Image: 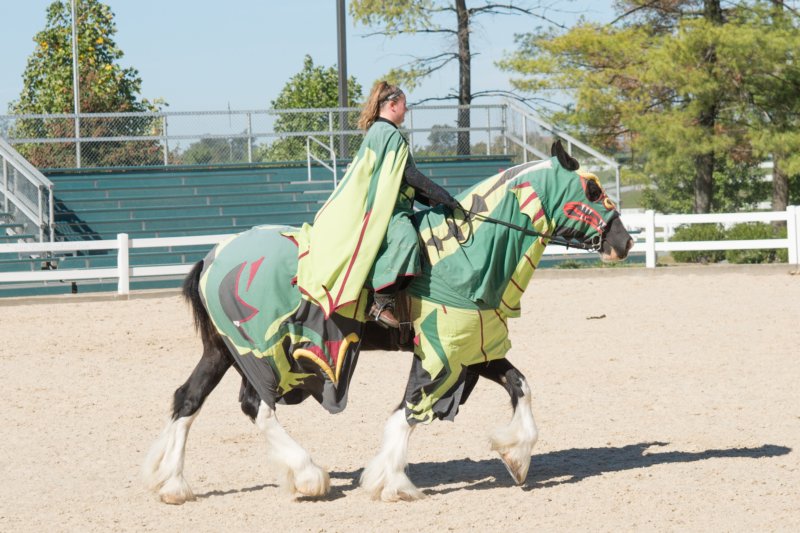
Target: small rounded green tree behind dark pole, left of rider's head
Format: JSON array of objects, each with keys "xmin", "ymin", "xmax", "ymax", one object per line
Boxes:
[{"xmin": 257, "ymin": 55, "xmax": 362, "ymax": 161}]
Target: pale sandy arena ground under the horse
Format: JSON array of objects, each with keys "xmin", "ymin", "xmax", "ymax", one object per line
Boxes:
[{"xmin": 0, "ymin": 266, "xmax": 800, "ymax": 532}]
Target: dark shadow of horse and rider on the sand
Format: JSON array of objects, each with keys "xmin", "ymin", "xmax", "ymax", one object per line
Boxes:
[{"xmin": 192, "ymin": 441, "xmax": 792, "ymax": 501}]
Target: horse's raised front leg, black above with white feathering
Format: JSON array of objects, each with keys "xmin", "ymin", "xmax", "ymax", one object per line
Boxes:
[{"xmin": 470, "ymin": 359, "xmax": 538, "ymax": 485}]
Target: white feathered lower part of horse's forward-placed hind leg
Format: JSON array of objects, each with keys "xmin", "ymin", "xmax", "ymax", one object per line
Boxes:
[{"xmin": 250, "ymin": 400, "xmax": 330, "ymax": 497}]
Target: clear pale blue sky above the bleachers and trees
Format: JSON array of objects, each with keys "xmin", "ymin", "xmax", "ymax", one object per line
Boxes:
[{"xmin": 0, "ymin": 0, "xmax": 613, "ymax": 114}]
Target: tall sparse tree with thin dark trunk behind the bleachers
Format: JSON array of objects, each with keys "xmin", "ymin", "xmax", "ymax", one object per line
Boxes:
[{"xmin": 350, "ymin": 0, "xmax": 564, "ymax": 155}]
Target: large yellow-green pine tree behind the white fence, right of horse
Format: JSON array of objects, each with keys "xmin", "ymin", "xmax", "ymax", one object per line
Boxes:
[{"xmin": 501, "ymin": 0, "xmax": 798, "ymax": 213}]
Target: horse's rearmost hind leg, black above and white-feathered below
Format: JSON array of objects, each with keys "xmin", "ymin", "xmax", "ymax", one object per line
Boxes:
[{"xmin": 142, "ymin": 339, "xmax": 232, "ymax": 504}]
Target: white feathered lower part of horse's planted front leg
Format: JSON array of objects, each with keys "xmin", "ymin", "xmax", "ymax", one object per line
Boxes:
[{"xmin": 361, "ymin": 406, "xmax": 425, "ymax": 502}]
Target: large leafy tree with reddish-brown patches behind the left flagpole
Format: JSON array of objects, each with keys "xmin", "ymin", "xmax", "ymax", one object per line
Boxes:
[{"xmin": 9, "ymin": 0, "xmax": 161, "ymax": 167}]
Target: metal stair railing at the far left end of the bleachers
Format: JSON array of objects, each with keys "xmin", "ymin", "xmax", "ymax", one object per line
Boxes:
[{"xmin": 0, "ymin": 138, "xmax": 55, "ymax": 242}]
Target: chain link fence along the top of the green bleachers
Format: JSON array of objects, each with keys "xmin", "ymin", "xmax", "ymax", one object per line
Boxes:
[{"xmin": 0, "ymin": 105, "xmax": 507, "ymax": 168}]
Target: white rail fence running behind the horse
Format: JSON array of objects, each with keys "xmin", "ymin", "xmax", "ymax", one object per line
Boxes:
[{"xmin": 0, "ymin": 206, "xmax": 800, "ymax": 296}]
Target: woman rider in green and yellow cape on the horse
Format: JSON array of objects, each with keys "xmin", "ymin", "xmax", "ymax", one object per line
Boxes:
[{"xmin": 297, "ymin": 81, "xmax": 459, "ymax": 328}]
